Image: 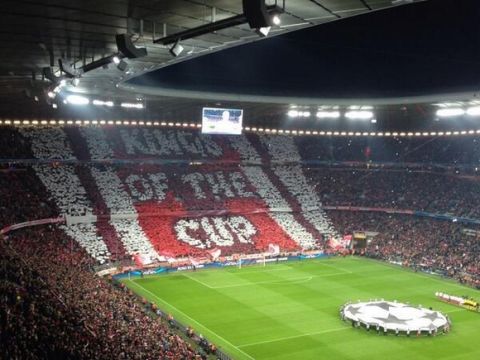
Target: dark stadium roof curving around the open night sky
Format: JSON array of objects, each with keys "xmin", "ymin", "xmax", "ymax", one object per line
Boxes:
[{"xmin": 0, "ymin": 0, "xmax": 478, "ymax": 129}]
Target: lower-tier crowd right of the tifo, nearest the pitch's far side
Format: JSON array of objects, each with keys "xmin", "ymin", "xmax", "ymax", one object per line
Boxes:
[{"xmin": 328, "ymin": 211, "xmax": 480, "ymax": 287}]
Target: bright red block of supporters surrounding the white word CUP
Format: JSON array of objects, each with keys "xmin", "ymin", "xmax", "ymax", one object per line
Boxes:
[{"xmin": 129, "ymin": 166, "xmax": 298, "ymax": 257}]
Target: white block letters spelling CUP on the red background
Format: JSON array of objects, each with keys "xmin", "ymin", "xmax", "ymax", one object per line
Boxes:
[{"xmin": 175, "ymin": 216, "xmax": 257, "ymax": 249}]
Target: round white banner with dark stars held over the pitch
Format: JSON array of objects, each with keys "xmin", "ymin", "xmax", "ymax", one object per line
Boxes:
[{"xmin": 340, "ymin": 300, "xmax": 450, "ymax": 336}]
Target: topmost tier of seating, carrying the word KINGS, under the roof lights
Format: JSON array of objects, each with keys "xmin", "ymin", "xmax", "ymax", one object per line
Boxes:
[{"xmin": 0, "ymin": 126, "xmax": 480, "ymax": 165}]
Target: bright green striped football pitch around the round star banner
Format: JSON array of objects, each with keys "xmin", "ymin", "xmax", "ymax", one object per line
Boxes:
[{"xmin": 124, "ymin": 257, "xmax": 480, "ymax": 360}]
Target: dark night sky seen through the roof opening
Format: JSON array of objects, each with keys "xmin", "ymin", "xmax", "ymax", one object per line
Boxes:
[{"xmin": 133, "ymin": 0, "xmax": 480, "ymax": 98}]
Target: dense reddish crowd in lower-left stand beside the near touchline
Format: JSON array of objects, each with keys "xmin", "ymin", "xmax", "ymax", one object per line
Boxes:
[{"xmin": 0, "ymin": 227, "xmax": 204, "ymax": 360}]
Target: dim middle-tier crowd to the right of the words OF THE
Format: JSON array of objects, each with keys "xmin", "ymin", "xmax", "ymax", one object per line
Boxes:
[{"xmin": 305, "ymin": 167, "xmax": 480, "ymax": 219}]
